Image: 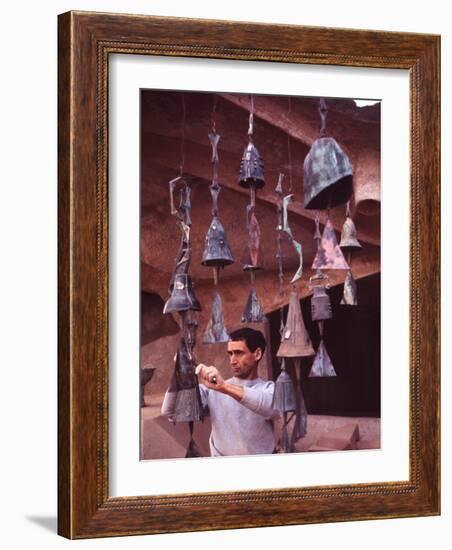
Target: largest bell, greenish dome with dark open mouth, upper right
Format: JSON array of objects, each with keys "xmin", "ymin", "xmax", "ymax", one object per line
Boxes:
[{"xmin": 303, "ymin": 137, "xmax": 353, "ymax": 210}]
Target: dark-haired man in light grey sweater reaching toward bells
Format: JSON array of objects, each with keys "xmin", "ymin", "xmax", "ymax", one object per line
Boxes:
[{"xmin": 162, "ymin": 328, "xmax": 279, "ymax": 456}]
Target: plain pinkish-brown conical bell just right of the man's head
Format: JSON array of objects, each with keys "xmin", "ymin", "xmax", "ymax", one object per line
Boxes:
[{"xmin": 276, "ymin": 291, "xmax": 315, "ymax": 357}]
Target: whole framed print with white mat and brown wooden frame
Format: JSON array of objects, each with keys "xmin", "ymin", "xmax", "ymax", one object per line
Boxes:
[{"xmin": 59, "ymin": 12, "xmax": 439, "ymax": 538}]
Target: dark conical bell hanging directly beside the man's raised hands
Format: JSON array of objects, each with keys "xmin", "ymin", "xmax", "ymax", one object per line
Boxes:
[{"xmin": 172, "ymin": 338, "xmax": 204, "ymax": 422}]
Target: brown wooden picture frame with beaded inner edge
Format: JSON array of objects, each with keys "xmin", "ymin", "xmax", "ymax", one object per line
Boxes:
[{"xmin": 58, "ymin": 12, "xmax": 440, "ymax": 538}]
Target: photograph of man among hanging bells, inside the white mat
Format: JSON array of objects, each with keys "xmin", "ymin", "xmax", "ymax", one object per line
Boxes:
[{"xmin": 140, "ymin": 89, "xmax": 381, "ymax": 460}]
